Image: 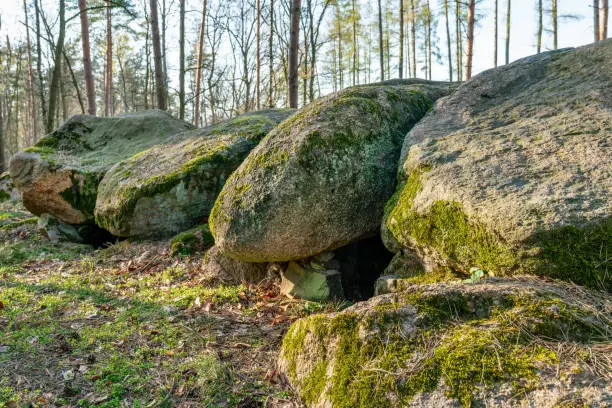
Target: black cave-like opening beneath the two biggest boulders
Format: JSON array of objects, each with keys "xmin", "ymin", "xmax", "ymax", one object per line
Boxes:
[{"xmin": 334, "ymin": 234, "xmax": 393, "ymax": 301}]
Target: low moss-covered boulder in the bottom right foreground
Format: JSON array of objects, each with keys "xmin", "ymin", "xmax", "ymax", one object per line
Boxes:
[{"xmin": 278, "ymin": 278, "xmax": 612, "ymax": 408}]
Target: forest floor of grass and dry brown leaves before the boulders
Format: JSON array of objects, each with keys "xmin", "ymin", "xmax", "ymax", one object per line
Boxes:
[{"xmin": 0, "ymin": 197, "xmax": 340, "ymax": 408}]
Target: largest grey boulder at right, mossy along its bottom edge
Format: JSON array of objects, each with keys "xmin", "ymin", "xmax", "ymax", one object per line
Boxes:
[{"xmin": 382, "ymin": 40, "xmax": 612, "ymax": 290}]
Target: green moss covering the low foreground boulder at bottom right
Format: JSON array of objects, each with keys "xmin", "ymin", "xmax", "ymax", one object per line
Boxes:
[{"xmin": 282, "ymin": 291, "xmax": 607, "ymax": 407}]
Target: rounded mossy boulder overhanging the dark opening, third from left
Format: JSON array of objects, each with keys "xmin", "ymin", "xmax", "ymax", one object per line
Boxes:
[{"xmin": 210, "ymin": 80, "xmax": 450, "ymax": 262}]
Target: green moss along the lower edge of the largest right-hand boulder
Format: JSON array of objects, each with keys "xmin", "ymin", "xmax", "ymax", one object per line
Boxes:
[{"xmin": 384, "ymin": 165, "xmax": 612, "ymax": 290}]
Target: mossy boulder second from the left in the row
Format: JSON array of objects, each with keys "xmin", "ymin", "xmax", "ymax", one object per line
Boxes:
[{"xmin": 95, "ymin": 109, "xmax": 294, "ymax": 237}]
